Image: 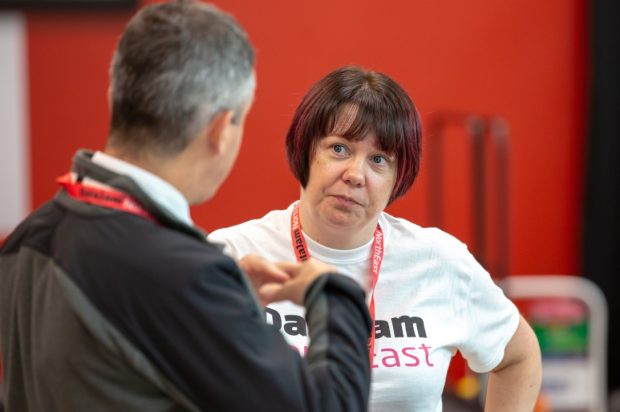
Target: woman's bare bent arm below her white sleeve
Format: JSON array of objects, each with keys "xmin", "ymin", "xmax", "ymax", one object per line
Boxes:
[{"xmin": 484, "ymin": 317, "xmax": 542, "ymax": 412}]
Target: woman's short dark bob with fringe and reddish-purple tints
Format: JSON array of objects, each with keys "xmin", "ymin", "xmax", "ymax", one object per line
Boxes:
[{"xmin": 286, "ymin": 66, "xmax": 422, "ymax": 203}]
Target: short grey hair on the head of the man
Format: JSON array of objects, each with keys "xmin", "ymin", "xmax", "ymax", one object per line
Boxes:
[{"xmin": 108, "ymin": 0, "xmax": 256, "ymax": 155}]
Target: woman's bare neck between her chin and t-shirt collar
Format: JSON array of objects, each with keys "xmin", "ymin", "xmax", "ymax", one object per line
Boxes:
[{"xmin": 298, "ymin": 200, "xmax": 377, "ymax": 250}]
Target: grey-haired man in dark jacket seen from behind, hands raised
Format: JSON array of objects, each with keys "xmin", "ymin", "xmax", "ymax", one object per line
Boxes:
[{"xmin": 0, "ymin": 0, "xmax": 370, "ymax": 411}]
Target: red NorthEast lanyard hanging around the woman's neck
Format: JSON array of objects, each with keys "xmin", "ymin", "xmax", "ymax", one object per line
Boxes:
[{"xmin": 291, "ymin": 205, "xmax": 383, "ymax": 367}]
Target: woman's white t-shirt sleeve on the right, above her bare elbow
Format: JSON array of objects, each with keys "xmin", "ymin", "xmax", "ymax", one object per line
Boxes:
[{"xmin": 460, "ymin": 252, "xmax": 520, "ymax": 373}]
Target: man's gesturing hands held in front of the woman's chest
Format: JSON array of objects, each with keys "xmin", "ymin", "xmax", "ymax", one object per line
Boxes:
[{"xmin": 257, "ymin": 258, "xmax": 336, "ymax": 305}]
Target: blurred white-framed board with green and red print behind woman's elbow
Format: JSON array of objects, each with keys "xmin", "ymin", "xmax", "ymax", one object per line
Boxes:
[{"xmin": 501, "ymin": 275, "xmax": 608, "ymax": 412}]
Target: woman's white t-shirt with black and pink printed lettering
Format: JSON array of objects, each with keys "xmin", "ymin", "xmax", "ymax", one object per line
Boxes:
[{"xmin": 209, "ymin": 204, "xmax": 519, "ymax": 412}]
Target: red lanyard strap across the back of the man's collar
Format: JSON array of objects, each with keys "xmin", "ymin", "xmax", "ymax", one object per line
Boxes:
[{"xmin": 56, "ymin": 173, "xmax": 156, "ymax": 222}]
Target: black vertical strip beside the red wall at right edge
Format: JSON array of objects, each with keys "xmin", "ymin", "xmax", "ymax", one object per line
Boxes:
[{"xmin": 582, "ymin": 0, "xmax": 620, "ymax": 412}]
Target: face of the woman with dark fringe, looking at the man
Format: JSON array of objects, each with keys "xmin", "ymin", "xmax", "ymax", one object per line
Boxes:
[{"xmin": 301, "ymin": 133, "xmax": 397, "ymax": 235}]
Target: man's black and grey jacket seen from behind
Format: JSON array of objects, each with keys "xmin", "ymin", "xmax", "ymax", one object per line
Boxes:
[{"xmin": 0, "ymin": 151, "xmax": 370, "ymax": 412}]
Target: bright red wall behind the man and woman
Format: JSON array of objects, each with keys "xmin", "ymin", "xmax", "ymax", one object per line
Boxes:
[{"xmin": 27, "ymin": 0, "xmax": 588, "ymax": 274}]
